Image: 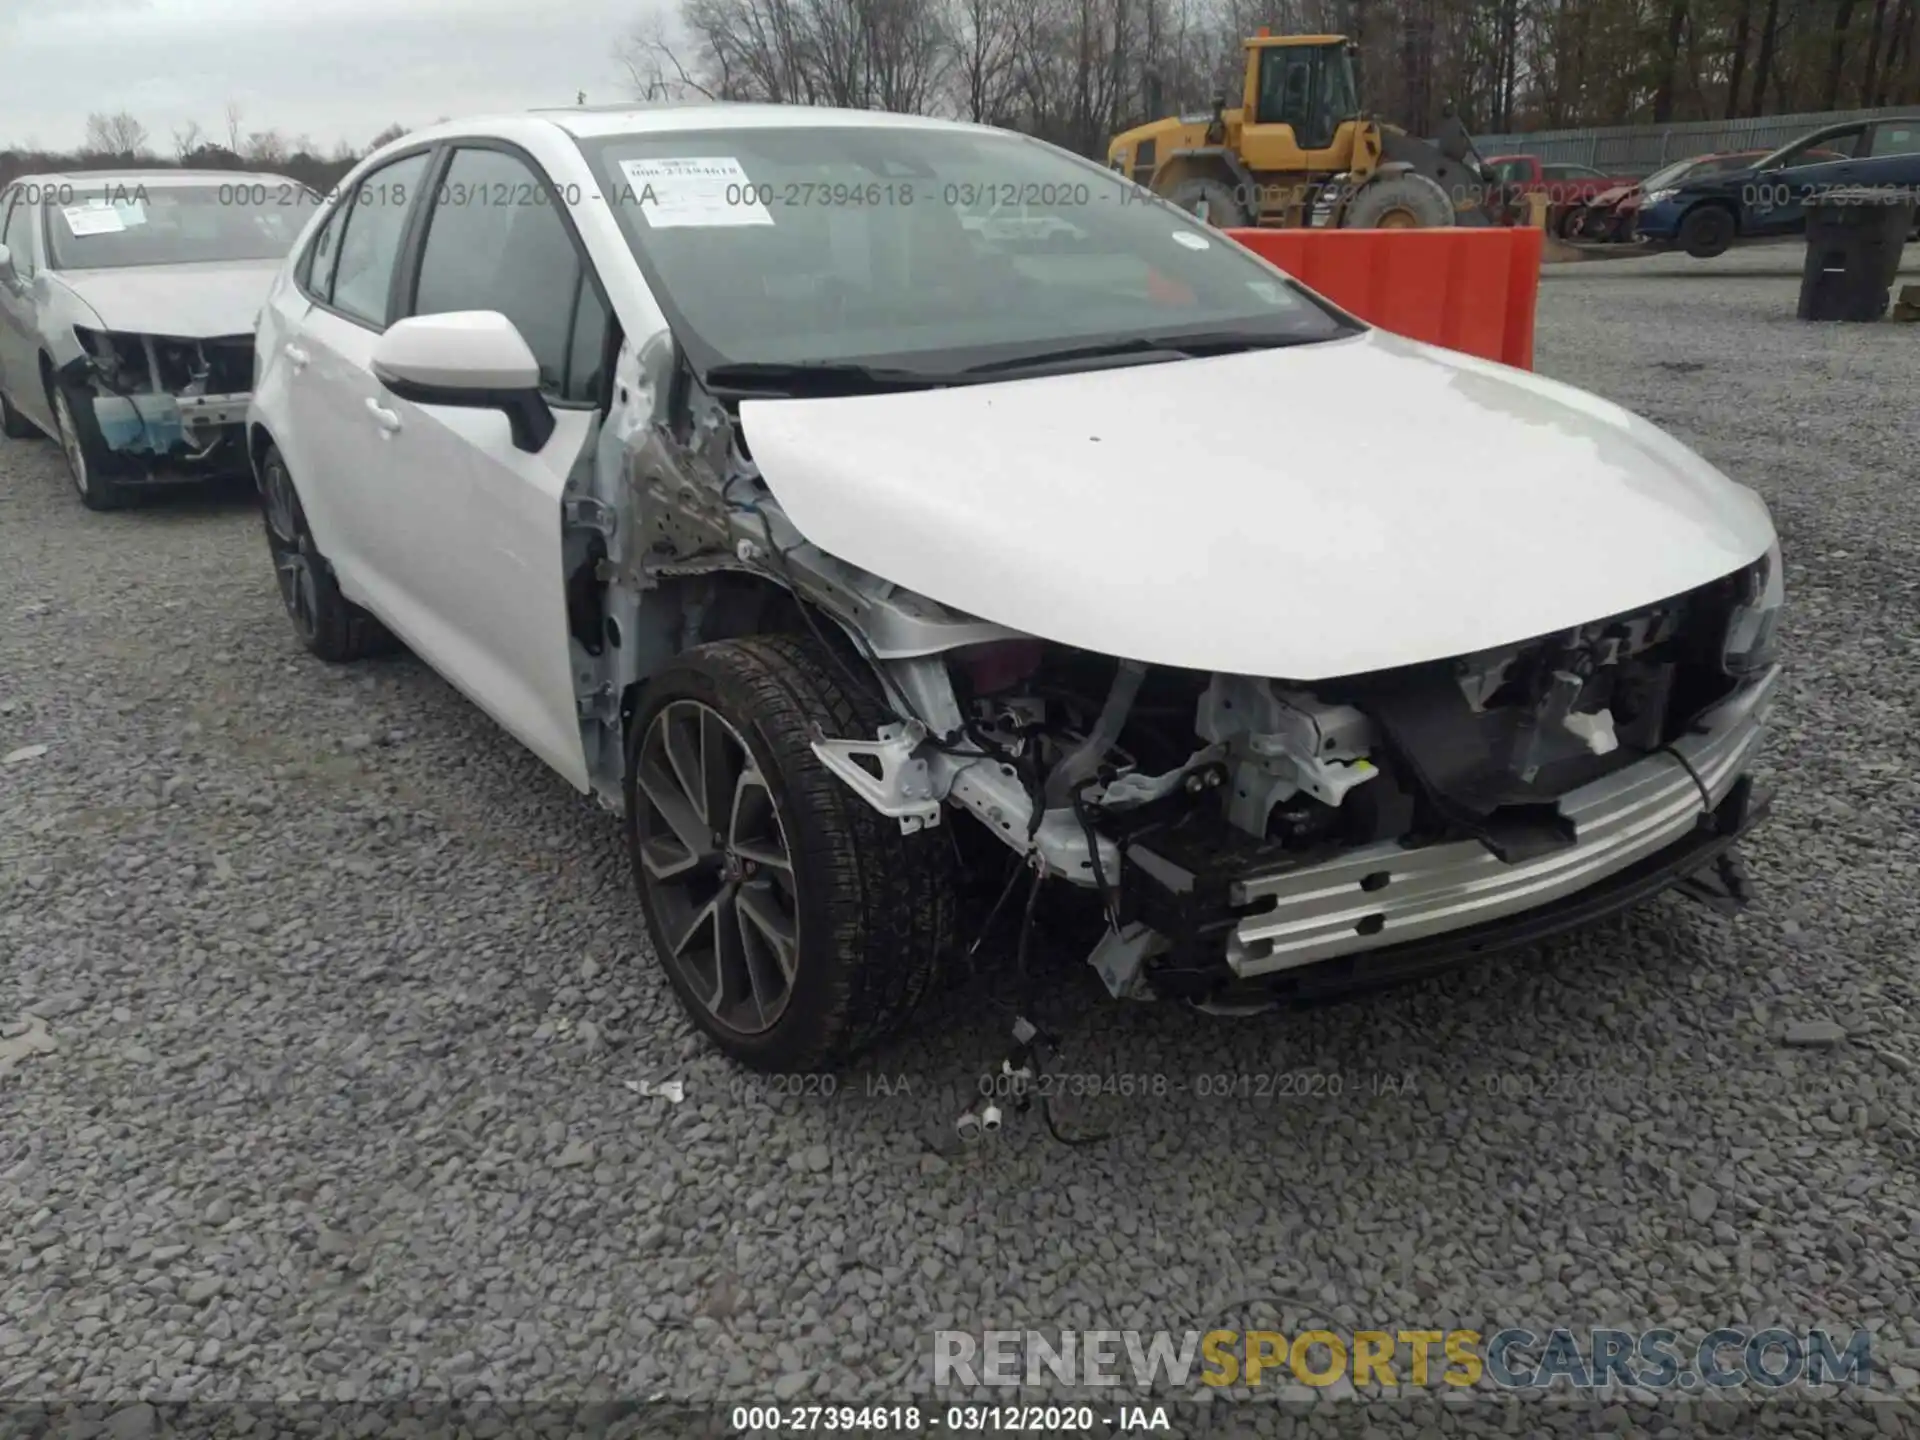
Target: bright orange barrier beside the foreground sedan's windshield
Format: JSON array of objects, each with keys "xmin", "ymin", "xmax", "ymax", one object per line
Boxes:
[{"xmin": 1227, "ymin": 225, "xmax": 1542, "ymax": 371}]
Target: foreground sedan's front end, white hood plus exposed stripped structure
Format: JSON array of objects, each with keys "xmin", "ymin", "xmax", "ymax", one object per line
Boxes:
[{"xmin": 566, "ymin": 318, "xmax": 1784, "ymax": 1008}]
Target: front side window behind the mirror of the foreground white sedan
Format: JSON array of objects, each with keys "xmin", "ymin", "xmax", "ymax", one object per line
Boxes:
[{"xmin": 411, "ymin": 148, "xmax": 607, "ymax": 399}]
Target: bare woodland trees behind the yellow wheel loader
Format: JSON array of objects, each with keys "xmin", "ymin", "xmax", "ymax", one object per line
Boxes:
[{"xmin": 620, "ymin": 0, "xmax": 1920, "ymax": 156}]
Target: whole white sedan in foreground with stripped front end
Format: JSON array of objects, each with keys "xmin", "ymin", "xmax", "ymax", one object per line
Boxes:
[{"xmin": 248, "ymin": 106, "xmax": 1782, "ymax": 1071}]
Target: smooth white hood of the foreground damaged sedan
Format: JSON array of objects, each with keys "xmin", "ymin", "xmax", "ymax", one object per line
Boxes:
[{"xmin": 741, "ymin": 330, "xmax": 1774, "ymax": 680}]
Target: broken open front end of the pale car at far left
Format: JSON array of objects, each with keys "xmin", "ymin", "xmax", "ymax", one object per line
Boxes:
[{"xmin": 61, "ymin": 326, "xmax": 253, "ymax": 467}]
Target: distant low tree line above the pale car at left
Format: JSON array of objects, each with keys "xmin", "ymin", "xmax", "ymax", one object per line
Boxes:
[{"xmin": 0, "ymin": 104, "xmax": 407, "ymax": 194}]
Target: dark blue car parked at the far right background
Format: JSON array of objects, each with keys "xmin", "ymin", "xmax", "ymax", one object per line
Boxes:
[{"xmin": 1636, "ymin": 115, "xmax": 1920, "ymax": 259}]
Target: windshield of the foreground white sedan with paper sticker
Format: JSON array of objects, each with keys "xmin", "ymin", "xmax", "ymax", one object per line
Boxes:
[{"xmin": 584, "ymin": 127, "xmax": 1357, "ymax": 372}]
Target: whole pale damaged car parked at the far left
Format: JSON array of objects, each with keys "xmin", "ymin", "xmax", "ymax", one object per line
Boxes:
[{"xmin": 0, "ymin": 169, "xmax": 319, "ymax": 511}]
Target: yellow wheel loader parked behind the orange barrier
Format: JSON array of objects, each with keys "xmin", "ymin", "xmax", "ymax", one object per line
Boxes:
[{"xmin": 1106, "ymin": 29, "xmax": 1511, "ymax": 228}]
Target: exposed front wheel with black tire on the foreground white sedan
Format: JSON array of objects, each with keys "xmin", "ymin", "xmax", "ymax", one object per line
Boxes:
[{"xmin": 626, "ymin": 636, "xmax": 954, "ymax": 1073}]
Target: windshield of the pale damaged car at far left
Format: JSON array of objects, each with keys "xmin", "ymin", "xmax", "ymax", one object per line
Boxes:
[{"xmin": 46, "ymin": 177, "xmax": 317, "ymax": 271}]
